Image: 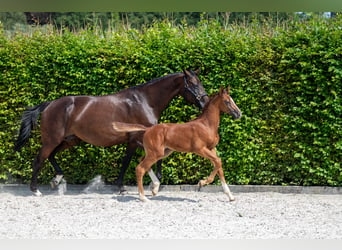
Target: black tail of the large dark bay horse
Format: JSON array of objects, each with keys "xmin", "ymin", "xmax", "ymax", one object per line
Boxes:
[{"xmin": 14, "ymin": 102, "xmax": 50, "ymax": 151}]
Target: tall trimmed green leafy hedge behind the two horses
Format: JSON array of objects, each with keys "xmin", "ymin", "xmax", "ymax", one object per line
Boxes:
[{"xmin": 0, "ymin": 17, "xmax": 342, "ymax": 186}]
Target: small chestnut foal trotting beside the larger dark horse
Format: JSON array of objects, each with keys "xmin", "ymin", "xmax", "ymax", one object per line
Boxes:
[{"xmin": 113, "ymin": 88, "xmax": 241, "ymax": 201}]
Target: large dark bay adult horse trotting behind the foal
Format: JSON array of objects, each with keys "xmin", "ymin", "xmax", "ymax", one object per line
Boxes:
[{"xmin": 15, "ymin": 70, "xmax": 209, "ymax": 196}]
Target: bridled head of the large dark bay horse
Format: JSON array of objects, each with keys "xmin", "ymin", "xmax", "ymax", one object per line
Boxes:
[{"xmin": 180, "ymin": 69, "xmax": 209, "ymax": 108}]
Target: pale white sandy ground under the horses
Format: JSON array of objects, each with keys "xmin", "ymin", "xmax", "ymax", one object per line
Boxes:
[{"xmin": 0, "ymin": 182, "xmax": 342, "ymax": 239}]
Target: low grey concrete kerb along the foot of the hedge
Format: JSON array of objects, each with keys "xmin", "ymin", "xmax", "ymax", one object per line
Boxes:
[{"xmin": 0, "ymin": 184, "xmax": 342, "ymax": 195}]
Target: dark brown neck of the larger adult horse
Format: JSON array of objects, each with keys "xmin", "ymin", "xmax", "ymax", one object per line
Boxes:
[{"xmin": 141, "ymin": 74, "xmax": 180, "ymax": 118}]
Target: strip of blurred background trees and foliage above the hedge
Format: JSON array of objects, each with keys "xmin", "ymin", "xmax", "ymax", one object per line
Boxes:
[{"xmin": 0, "ymin": 12, "xmax": 296, "ymax": 31}]
